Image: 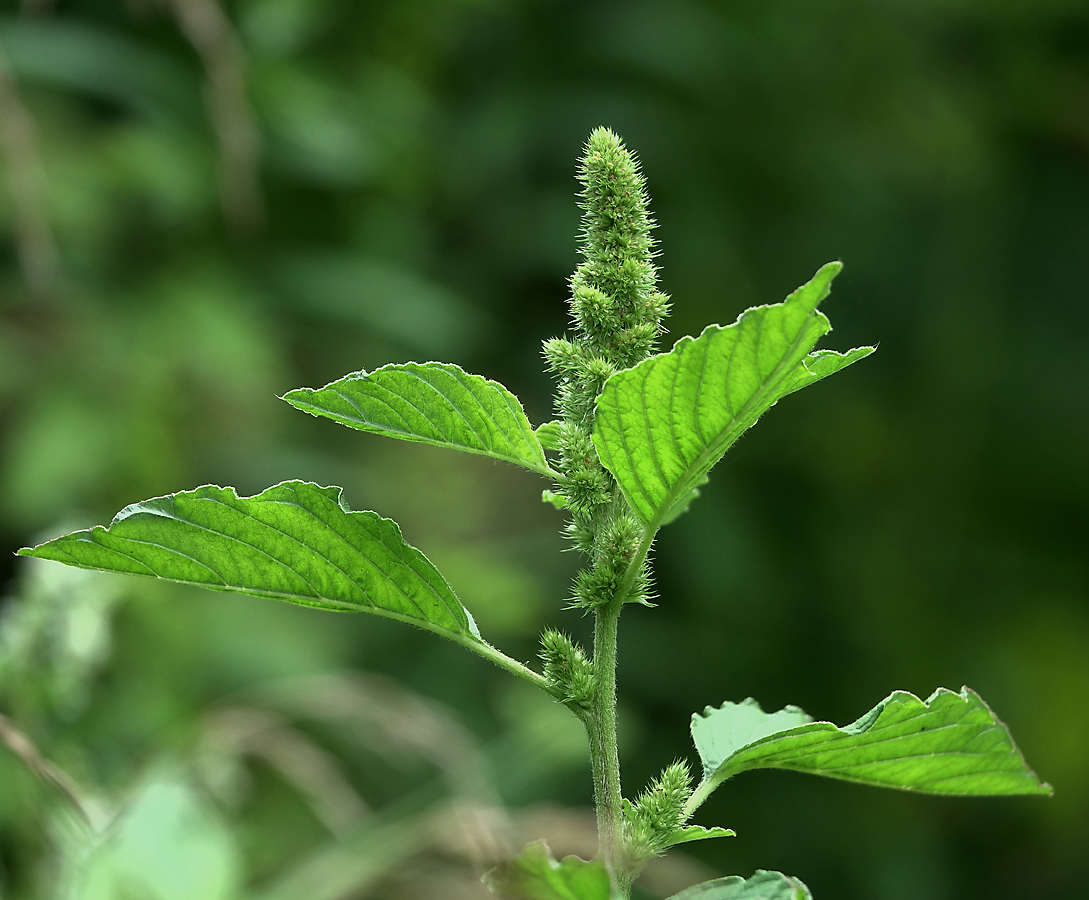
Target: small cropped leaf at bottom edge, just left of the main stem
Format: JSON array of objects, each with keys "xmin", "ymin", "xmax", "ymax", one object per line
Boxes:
[{"xmin": 484, "ymin": 841, "xmax": 612, "ymax": 900}]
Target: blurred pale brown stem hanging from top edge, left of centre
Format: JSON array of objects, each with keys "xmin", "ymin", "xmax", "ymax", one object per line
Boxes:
[{"xmin": 170, "ymin": 0, "xmax": 265, "ymax": 232}]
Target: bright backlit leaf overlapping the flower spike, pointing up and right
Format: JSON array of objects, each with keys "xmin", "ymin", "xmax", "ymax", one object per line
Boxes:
[{"xmin": 594, "ymin": 263, "xmax": 873, "ymax": 528}]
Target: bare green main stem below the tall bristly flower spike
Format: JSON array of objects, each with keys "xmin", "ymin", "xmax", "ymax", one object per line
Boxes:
[{"xmin": 587, "ymin": 600, "xmax": 626, "ymax": 896}]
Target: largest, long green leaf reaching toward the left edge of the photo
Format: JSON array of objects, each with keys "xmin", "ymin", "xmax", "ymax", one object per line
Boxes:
[{"xmin": 20, "ymin": 482, "xmax": 479, "ymax": 642}]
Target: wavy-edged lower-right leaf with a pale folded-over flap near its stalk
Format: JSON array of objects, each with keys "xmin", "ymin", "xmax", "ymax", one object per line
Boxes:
[{"xmin": 687, "ymin": 688, "xmax": 1051, "ymax": 812}]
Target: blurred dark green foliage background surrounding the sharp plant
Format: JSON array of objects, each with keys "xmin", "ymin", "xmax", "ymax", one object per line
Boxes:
[{"xmin": 0, "ymin": 0, "xmax": 1089, "ymax": 900}]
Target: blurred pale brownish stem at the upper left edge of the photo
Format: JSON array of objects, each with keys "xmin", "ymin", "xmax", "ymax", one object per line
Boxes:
[{"xmin": 0, "ymin": 46, "xmax": 60, "ymax": 297}]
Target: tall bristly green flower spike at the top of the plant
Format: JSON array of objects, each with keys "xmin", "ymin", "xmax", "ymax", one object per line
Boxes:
[{"xmin": 545, "ymin": 129, "xmax": 670, "ymax": 608}]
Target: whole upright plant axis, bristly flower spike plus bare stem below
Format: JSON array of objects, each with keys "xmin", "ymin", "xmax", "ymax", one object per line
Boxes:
[{"xmin": 544, "ymin": 129, "xmax": 670, "ymax": 898}]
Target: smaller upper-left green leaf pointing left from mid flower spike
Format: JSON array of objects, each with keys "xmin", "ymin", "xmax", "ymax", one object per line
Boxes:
[{"xmin": 283, "ymin": 363, "xmax": 555, "ymax": 476}]
